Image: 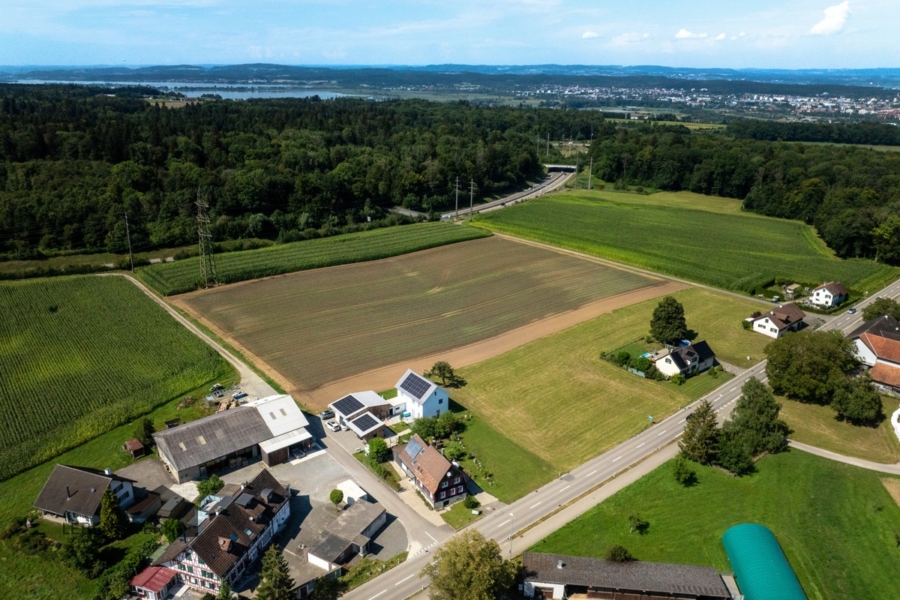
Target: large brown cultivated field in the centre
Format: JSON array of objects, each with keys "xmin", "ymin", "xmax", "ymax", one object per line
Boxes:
[{"xmin": 179, "ymin": 238, "xmax": 658, "ymax": 390}]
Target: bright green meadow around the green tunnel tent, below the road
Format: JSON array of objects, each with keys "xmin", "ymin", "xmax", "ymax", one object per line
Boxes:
[{"xmin": 531, "ymin": 450, "xmax": 900, "ymax": 600}]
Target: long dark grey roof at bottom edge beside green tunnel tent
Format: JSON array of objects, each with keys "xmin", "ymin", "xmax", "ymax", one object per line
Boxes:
[{"xmin": 522, "ymin": 552, "xmax": 731, "ymax": 600}]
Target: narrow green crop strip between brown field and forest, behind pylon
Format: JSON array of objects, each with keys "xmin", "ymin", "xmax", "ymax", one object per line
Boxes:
[{"xmin": 138, "ymin": 223, "xmax": 486, "ymax": 296}]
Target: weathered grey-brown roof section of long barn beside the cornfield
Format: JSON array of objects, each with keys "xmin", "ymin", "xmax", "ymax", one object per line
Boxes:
[{"xmin": 153, "ymin": 406, "xmax": 272, "ymax": 471}]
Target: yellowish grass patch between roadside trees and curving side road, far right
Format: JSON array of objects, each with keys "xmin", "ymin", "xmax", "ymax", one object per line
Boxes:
[{"xmin": 779, "ymin": 397, "xmax": 900, "ymax": 464}]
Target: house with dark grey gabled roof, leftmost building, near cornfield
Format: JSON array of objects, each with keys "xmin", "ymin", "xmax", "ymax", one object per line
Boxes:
[{"xmin": 34, "ymin": 465, "xmax": 134, "ymax": 527}]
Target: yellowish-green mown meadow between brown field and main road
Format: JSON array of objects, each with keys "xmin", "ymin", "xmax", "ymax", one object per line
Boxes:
[{"xmin": 452, "ymin": 288, "xmax": 771, "ymax": 488}]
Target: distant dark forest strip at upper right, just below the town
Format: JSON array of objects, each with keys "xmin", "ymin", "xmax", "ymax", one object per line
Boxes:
[{"xmin": 727, "ymin": 119, "xmax": 900, "ymax": 146}]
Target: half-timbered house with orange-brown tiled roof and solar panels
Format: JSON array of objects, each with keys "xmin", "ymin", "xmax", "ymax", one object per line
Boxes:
[{"xmin": 392, "ymin": 434, "xmax": 466, "ymax": 508}]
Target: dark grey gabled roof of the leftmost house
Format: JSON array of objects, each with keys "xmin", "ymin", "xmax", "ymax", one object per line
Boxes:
[{"xmin": 34, "ymin": 465, "xmax": 123, "ymax": 517}]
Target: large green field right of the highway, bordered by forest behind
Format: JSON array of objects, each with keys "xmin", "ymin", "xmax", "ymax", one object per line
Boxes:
[{"xmin": 476, "ymin": 190, "xmax": 900, "ymax": 292}]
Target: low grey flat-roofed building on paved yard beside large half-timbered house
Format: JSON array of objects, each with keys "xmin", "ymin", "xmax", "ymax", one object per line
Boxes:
[{"xmin": 302, "ymin": 499, "xmax": 387, "ymax": 572}]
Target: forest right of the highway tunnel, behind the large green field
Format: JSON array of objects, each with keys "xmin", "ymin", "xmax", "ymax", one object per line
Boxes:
[{"xmin": 591, "ymin": 125, "xmax": 900, "ymax": 264}]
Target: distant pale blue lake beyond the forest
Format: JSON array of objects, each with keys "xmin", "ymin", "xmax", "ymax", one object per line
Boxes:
[{"xmin": 16, "ymin": 79, "xmax": 352, "ymax": 100}]
